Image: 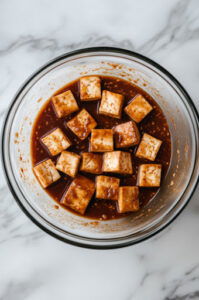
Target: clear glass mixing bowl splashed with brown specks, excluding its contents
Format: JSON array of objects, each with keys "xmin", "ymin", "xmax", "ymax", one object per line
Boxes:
[{"xmin": 2, "ymin": 47, "xmax": 199, "ymax": 249}]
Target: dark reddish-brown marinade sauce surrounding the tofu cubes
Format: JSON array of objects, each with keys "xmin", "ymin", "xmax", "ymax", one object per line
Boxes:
[{"xmin": 31, "ymin": 76, "xmax": 171, "ymax": 219}]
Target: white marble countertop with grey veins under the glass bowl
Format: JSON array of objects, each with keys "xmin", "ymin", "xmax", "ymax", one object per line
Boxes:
[{"xmin": 0, "ymin": 0, "xmax": 199, "ymax": 300}]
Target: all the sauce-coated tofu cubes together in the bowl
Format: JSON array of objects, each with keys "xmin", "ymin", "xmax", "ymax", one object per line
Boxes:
[{"xmin": 34, "ymin": 76, "xmax": 162, "ymax": 215}]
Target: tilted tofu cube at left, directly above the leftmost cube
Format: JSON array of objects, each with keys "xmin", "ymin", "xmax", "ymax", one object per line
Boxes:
[{"xmin": 41, "ymin": 128, "xmax": 71, "ymax": 156}]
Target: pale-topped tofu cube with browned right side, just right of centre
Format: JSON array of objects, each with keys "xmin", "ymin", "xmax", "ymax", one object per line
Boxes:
[{"xmin": 102, "ymin": 151, "xmax": 133, "ymax": 174}]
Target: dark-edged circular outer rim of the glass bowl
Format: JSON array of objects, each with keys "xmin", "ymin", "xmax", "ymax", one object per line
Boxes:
[{"xmin": 1, "ymin": 46, "xmax": 199, "ymax": 250}]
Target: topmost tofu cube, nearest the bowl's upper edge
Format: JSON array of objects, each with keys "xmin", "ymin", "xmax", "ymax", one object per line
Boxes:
[{"xmin": 80, "ymin": 76, "xmax": 101, "ymax": 101}]
